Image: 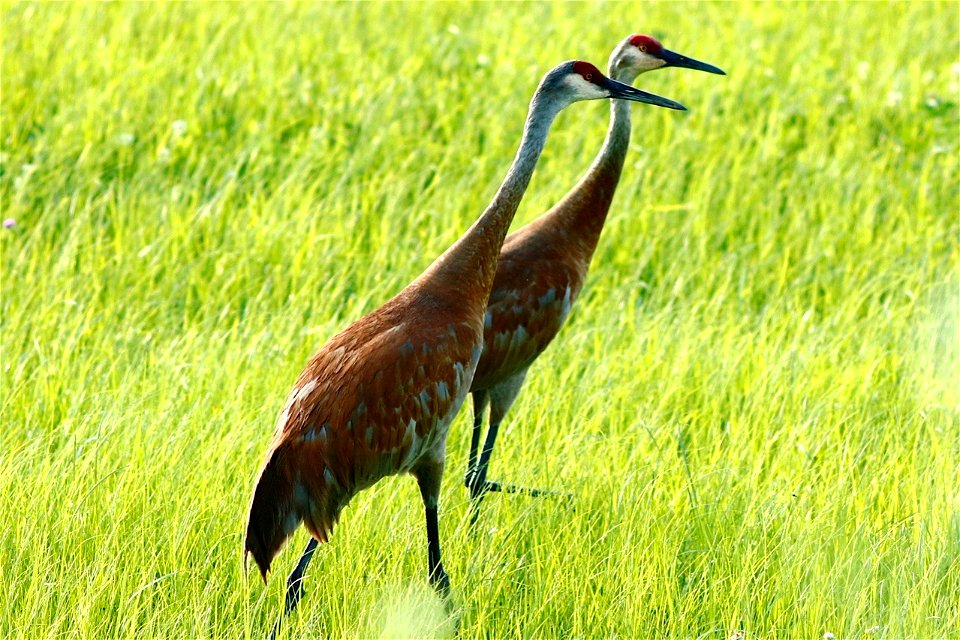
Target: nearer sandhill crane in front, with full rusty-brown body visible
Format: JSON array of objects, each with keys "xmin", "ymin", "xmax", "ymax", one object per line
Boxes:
[{"xmin": 244, "ymin": 61, "xmax": 684, "ymax": 635}]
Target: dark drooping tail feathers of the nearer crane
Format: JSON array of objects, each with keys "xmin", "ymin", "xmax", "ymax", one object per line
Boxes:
[{"xmin": 243, "ymin": 449, "xmax": 302, "ymax": 582}]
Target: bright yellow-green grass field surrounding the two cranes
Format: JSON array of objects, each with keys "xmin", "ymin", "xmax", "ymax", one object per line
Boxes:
[{"xmin": 0, "ymin": 2, "xmax": 960, "ymax": 639}]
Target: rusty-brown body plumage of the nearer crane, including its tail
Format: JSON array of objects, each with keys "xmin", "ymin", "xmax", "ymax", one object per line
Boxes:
[{"xmin": 246, "ymin": 290, "xmax": 480, "ymax": 577}]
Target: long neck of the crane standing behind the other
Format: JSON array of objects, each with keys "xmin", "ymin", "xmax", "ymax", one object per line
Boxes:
[{"xmin": 552, "ymin": 67, "xmax": 636, "ymax": 250}]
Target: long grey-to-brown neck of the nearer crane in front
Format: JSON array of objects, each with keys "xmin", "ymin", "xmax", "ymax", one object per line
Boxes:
[{"xmin": 417, "ymin": 92, "xmax": 563, "ymax": 308}]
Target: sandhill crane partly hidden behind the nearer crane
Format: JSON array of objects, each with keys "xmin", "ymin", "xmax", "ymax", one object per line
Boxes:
[{"xmin": 464, "ymin": 35, "xmax": 725, "ymax": 522}]
